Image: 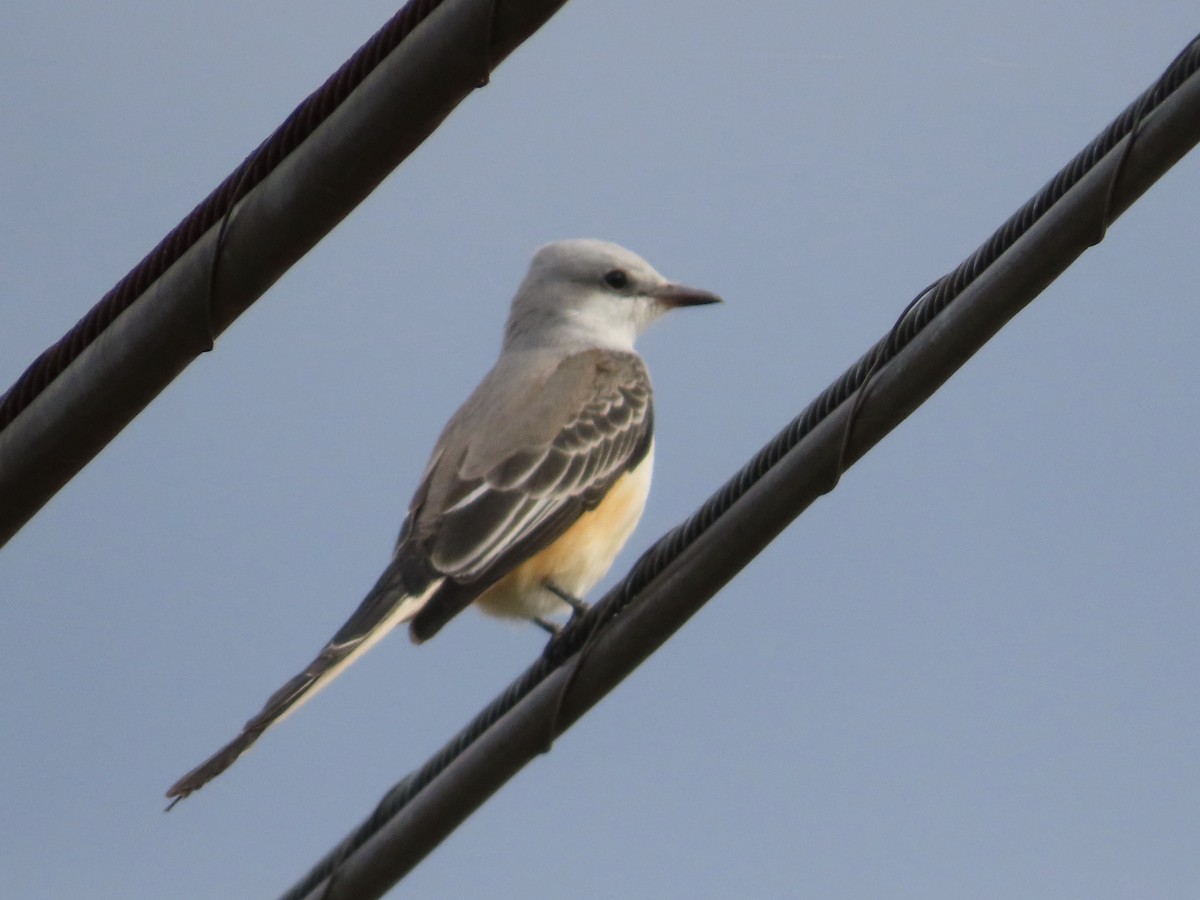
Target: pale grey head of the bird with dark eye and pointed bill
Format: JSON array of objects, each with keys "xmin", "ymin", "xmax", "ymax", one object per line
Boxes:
[{"xmin": 504, "ymin": 239, "xmax": 720, "ymax": 350}]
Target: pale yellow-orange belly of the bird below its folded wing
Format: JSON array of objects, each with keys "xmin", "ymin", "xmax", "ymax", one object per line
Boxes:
[{"xmin": 475, "ymin": 444, "xmax": 654, "ymax": 619}]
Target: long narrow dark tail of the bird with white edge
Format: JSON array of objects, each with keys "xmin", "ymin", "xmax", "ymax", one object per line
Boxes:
[{"xmin": 167, "ymin": 560, "xmax": 440, "ymax": 811}]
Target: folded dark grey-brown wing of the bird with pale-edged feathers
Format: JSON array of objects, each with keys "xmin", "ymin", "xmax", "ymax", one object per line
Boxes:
[{"xmin": 406, "ymin": 350, "xmax": 653, "ymax": 640}]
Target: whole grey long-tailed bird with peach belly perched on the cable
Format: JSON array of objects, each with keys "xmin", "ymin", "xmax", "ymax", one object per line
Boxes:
[{"xmin": 167, "ymin": 240, "xmax": 720, "ymax": 799}]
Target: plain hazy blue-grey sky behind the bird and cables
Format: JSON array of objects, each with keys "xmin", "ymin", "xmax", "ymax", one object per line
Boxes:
[{"xmin": 0, "ymin": 0, "xmax": 1200, "ymax": 900}]
